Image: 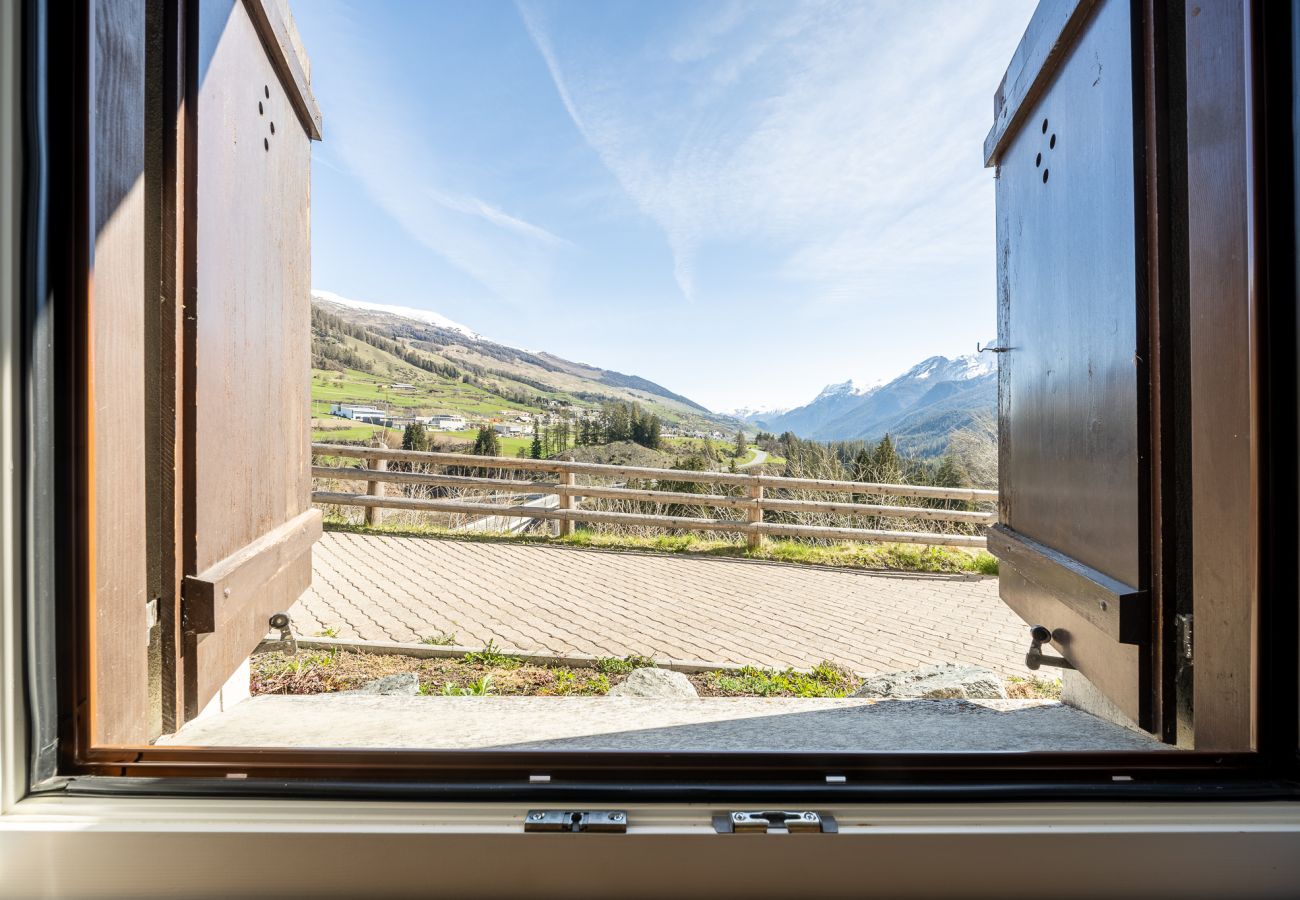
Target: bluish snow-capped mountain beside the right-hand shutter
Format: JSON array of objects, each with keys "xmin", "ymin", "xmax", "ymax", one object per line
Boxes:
[{"xmin": 746, "ymin": 345, "xmax": 997, "ymax": 454}]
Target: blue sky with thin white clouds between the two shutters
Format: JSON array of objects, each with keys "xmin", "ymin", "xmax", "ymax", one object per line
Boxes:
[{"xmin": 293, "ymin": 0, "xmax": 1034, "ymax": 410}]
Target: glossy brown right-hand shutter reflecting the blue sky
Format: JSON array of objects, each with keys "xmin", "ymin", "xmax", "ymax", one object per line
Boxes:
[{"xmin": 988, "ymin": 0, "xmax": 1152, "ymax": 728}]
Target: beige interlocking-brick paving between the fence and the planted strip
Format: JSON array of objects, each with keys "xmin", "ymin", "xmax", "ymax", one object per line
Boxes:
[{"xmin": 293, "ymin": 532, "xmax": 1028, "ymax": 675}]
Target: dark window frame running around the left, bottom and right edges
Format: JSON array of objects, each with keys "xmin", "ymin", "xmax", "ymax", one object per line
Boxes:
[{"xmin": 4, "ymin": 0, "xmax": 1300, "ymax": 804}]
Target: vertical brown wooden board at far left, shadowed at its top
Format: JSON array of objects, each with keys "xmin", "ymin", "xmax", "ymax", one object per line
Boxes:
[{"xmin": 81, "ymin": 0, "xmax": 152, "ymax": 745}]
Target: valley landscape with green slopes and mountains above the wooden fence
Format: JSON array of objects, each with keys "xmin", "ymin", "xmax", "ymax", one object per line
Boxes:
[{"xmin": 312, "ymin": 291, "xmax": 997, "ymax": 484}]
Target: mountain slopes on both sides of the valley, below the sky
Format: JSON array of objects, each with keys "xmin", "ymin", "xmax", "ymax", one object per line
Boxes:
[{"xmin": 312, "ymin": 290, "xmax": 997, "ymax": 457}]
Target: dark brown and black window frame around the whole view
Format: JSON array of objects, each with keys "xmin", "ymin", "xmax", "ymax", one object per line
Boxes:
[{"xmin": 12, "ymin": 0, "xmax": 1300, "ymax": 802}]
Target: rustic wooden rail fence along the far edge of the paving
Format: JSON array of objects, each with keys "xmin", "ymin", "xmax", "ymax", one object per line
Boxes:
[{"xmin": 312, "ymin": 443, "xmax": 997, "ymax": 548}]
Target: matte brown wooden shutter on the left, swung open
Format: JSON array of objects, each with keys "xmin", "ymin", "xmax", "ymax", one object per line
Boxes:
[{"xmin": 182, "ymin": 0, "xmax": 320, "ymax": 718}]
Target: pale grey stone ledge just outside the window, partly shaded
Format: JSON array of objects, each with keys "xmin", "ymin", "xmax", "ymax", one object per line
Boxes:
[{"xmin": 160, "ymin": 693, "xmax": 1164, "ymax": 753}]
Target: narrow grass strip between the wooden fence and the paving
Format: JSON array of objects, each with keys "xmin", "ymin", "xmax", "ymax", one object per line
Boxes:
[{"xmin": 325, "ymin": 518, "xmax": 997, "ymax": 575}]
